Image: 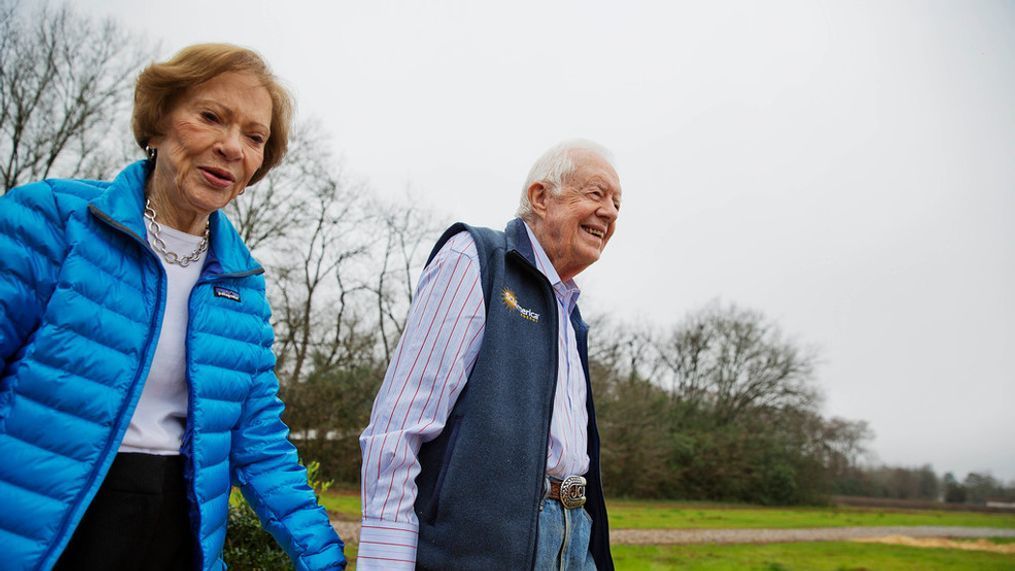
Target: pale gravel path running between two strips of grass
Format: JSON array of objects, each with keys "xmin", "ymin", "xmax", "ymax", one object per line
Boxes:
[{"xmin": 331, "ymin": 519, "xmax": 1015, "ymax": 546}]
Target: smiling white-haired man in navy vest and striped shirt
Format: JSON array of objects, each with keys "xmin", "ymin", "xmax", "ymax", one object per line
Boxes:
[{"xmin": 357, "ymin": 141, "xmax": 620, "ymax": 571}]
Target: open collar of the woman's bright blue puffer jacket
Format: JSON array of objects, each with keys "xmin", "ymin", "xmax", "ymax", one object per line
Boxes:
[{"xmin": 89, "ymin": 160, "xmax": 261, "ymax": 274}]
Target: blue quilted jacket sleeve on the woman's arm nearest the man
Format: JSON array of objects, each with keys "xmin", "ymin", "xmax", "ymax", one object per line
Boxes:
[{"xmin": 230, "ymin": 320, "xmax": 345, "ymax": 571}]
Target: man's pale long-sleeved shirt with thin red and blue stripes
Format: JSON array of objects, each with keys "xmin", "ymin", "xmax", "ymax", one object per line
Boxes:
[{"xmin": 356, "ymin": 225, "xmax": 589, "ymax": 571}]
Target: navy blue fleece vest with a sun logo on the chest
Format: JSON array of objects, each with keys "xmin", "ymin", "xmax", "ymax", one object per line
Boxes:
[{"xmin": 414, "ymin": 219, "xmax": 613, "ymax": 571}]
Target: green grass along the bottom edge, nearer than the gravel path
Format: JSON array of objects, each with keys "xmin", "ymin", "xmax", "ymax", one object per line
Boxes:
[{"xmin": 612, "ymin": 542, "xmax": 1015, "ymax": 571}]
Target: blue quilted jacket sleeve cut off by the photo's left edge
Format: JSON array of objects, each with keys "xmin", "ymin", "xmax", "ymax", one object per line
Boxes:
[{"xmin": 0, "ymin": 182, "xmax": 66, "ymax": 365}]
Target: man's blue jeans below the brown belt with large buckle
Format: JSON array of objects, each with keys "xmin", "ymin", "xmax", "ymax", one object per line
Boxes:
[{"xmin": 536, "ymin": 488, "xmax": 596, "ymax": 571}]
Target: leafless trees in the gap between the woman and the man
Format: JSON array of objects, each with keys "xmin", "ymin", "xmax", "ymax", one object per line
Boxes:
[{"xmin": 227, "ymin": 127, "xmax": 448, "ymax": 481}]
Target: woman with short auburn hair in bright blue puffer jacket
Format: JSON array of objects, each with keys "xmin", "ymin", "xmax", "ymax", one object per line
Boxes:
[{"xmin": 0, "ymin": 45, "xmax": 345, "ymax": 570}]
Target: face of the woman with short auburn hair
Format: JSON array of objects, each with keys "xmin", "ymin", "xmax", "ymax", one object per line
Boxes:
[{"xmin": 149, "ymin": 72, "xmax": 272, "ymax": 222}]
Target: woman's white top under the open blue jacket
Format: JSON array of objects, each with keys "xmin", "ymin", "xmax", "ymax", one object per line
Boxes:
[{"xmin": 120, "ymin": 226, "xmax": 208, "ymax": 455}]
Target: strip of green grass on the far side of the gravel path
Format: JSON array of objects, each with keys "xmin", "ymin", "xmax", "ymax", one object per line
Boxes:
[{"xmin": 321, "ymin": 493, "xmax": 1015, "ymax": 529}]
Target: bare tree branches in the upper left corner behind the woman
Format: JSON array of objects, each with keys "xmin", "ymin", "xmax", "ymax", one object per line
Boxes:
[{"xmin": 0, "ymin": 0, "xmax": 152, "ymax": 192}]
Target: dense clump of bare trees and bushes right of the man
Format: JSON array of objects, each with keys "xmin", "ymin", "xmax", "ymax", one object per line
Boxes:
[{"xmin": 591, "ymin": 303, "xmax": 870, "ymax": 504}]
